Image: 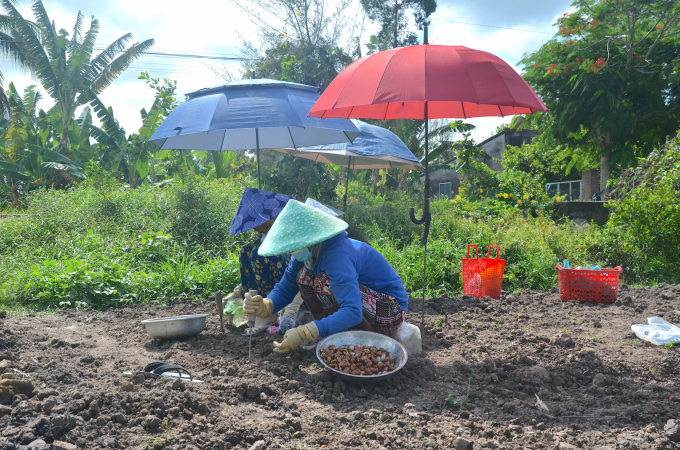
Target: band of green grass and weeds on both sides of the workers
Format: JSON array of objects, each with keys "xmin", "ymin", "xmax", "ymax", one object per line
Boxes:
[{"xmin": 0, "ymin": 178, "xmax": 599, "ymax": 310}]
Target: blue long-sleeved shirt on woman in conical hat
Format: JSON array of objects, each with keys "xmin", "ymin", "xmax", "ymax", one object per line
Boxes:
[{"xmin": 269, "ymin": 231, "xmax": 408, "ymax": 337}]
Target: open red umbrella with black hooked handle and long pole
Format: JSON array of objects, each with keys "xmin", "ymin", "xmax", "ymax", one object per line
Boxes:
[{"xmin": 309, "ymin": 26, "xmax": 548, "ymax": 324}]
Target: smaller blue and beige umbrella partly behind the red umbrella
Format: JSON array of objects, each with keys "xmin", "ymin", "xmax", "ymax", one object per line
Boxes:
[{"xmin": 276, "ymin": 119, "xmax": 424, "ymax": 211}]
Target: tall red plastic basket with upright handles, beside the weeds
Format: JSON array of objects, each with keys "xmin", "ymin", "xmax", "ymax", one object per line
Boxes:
[{"xmin": 461, "ymin": 244, "xmax": 505, "ymax": 298}]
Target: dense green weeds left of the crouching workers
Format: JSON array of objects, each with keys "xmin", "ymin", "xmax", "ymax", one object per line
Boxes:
[{"xmin": 0, "ymin": 177, "xmax": 247, "ymax": 308}]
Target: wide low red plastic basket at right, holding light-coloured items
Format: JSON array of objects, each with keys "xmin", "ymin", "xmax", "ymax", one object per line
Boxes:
[{"xmin": 556, "ymin": 264, "xmax": 623, "ymax": 305}]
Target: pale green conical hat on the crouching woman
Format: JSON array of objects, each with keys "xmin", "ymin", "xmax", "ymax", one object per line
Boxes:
[{"xmin": 257, "ymin": 200, "xmax": 348, "ymax": 256}]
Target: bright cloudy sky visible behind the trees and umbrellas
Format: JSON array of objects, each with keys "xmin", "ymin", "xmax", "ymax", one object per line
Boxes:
[{"xmin": 0, "ymin": 0, "xmax": 572, "ymax": 141}]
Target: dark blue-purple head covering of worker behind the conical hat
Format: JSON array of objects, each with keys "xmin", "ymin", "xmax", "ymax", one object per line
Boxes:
[{"xmin": 229, "ymin": 188, "xmax": 295, "ymax": 236}]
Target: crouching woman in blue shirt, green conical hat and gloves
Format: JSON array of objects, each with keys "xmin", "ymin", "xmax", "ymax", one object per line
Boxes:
[{"xmin": 243, "ymin": 200, "xmax": 408, "ymax": 353}]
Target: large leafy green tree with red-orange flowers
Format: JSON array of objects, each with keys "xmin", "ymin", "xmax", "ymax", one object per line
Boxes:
[{"xmin": 522, "ymin": 0, "xmax": 680, "ymax": 189}]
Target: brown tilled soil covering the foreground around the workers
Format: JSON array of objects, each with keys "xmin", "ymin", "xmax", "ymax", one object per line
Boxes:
[{"xmin": 0, "ymin": 285, "xmax": 680, "ymax": 450}]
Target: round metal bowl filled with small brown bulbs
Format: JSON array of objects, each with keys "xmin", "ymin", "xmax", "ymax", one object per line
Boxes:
[{"xmin": 316, "ymin": 331, "xmax": 408, "ymax": 382}]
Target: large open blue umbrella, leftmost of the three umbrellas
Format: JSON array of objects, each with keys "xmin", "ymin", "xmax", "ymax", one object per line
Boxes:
[{"xmin": 151, "ymin": 80, "xmax": 359, "ymax": 187}]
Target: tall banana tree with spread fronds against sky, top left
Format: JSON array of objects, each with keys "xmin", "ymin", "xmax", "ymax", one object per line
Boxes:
[{"xmin": 1, "ymin": 0, "xmax": 154, "ymax": 153}]
